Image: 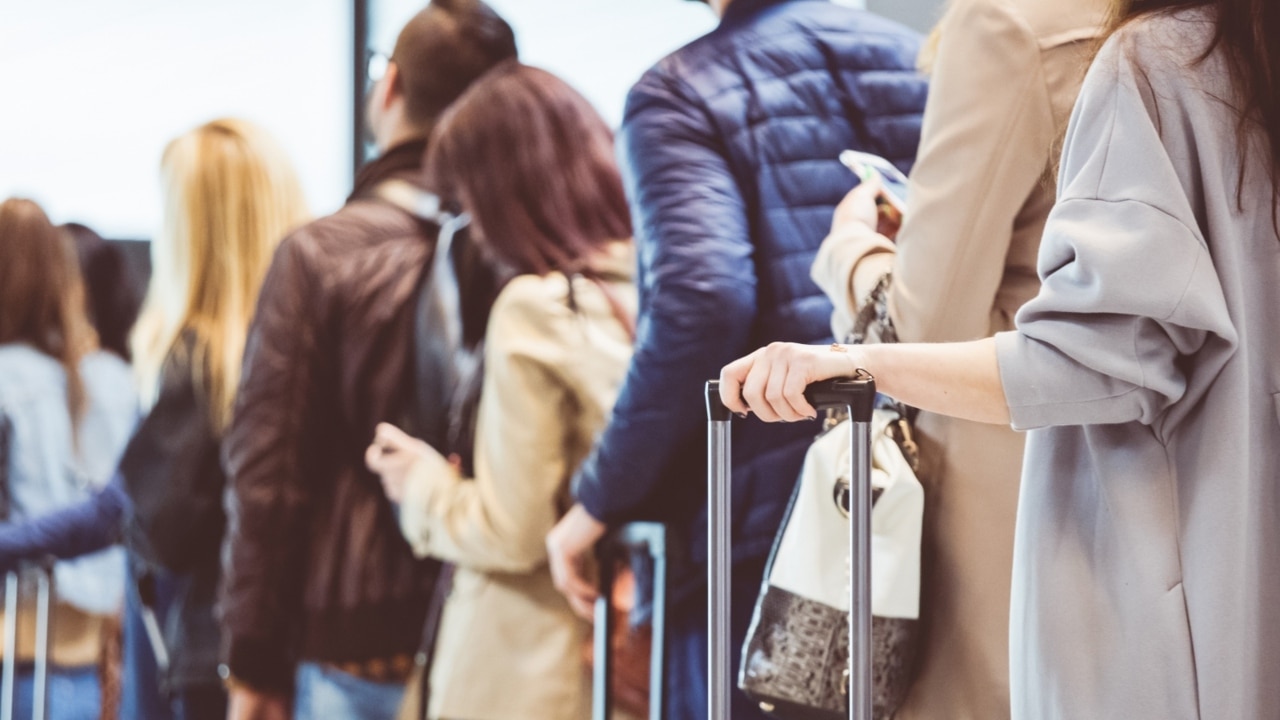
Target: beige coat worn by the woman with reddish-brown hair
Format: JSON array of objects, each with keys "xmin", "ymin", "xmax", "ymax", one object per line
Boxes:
[{"xmin": 389, "ymin": 242, "xmax": 636, "ymax": 720}]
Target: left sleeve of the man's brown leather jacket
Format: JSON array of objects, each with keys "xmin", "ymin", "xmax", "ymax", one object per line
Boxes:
[{"xmin": 221, "ymin": 231, "xmax": 324, "ymax": 692}]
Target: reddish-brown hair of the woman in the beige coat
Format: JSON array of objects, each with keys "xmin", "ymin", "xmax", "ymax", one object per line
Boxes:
[{"xmin": 426, "ymin": 61, "xmax": 631, "ymax": 275}]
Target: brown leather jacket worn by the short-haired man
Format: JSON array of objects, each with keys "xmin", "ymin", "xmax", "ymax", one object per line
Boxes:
[{"xmin": 221, "ymin": 142, "xmax": 439, "ymax": 692}]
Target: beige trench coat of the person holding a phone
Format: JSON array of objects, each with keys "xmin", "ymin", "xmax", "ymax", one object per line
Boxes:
[{"xmin": 813, "ymin": 0, "xmax": 1106, "ymax": 720}]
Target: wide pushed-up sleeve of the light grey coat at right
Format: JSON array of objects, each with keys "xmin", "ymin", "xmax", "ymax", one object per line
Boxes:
[{"xmin": 996, "ymin": 38, "xmax": 1238, "ymax": 432}]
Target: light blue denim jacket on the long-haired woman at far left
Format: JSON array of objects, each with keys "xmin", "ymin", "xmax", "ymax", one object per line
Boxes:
[{"xmin": 0, "ymin": 343, "xmax": 138, "ymax": 614}]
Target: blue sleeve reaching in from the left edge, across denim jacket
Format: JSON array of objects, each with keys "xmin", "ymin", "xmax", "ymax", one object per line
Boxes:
[{"xmin": 0, "ymin": 475, "xmax": 129, "ymax": 570}]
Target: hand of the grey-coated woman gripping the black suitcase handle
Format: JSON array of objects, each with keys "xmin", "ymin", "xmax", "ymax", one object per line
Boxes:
[{"xmin": 721, "ymin": 342, "xmax": 861, "ymax": 423}]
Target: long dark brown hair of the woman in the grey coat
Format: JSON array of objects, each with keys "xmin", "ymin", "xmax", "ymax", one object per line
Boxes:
[{"xmin": 1111, "ymin": 0, "xmax": 1280, "ymax": 215}]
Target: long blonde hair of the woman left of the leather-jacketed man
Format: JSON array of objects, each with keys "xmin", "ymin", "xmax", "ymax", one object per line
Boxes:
[{"xmin": 131, "ymin": 119, "xmax": 307, "ymax": 432}]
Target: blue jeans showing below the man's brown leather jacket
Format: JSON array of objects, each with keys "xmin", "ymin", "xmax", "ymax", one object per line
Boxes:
[{"xmin": 293, "ymin": 662, "xmax": 404, "ymax": 720}]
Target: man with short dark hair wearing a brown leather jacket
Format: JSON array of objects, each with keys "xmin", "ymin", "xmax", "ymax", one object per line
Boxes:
[{"xmin": 221, "ymin": 0, "xmax": 516, "ymax": 720}]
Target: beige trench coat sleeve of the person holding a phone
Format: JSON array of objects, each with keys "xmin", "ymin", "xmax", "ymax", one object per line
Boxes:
[{"xmin": 813, "ymin": 1, "xmax": 1060, "ymax": 342}]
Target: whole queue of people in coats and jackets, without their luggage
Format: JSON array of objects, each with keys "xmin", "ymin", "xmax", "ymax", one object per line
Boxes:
[{"xmin": 0, "ymin": 0, "xmax": 1280, "ymax": 720}]
